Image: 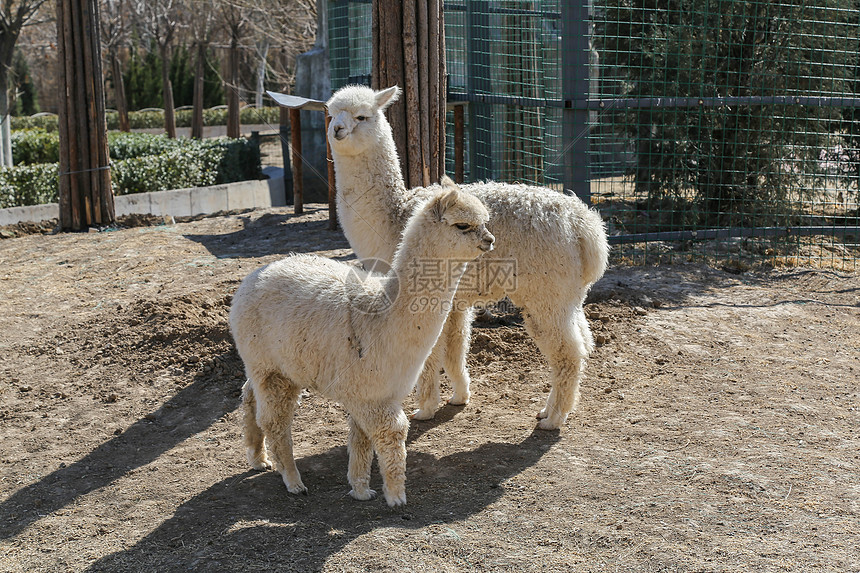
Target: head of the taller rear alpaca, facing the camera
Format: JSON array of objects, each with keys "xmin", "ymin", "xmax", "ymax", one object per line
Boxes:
[{"xmin": 326, "ymin": 86, "xmax": 400, "ymax": 155}]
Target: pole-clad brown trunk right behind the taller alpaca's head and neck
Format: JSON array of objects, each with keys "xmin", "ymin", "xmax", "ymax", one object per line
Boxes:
[{"xmin": 372, "ymin": 0, "xmax": 447, "ymax": 187}]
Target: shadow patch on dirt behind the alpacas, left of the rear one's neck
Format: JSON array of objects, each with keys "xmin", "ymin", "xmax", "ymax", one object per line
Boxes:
[{"xmin": 185, "ymin": 208, "xmax": 349, "ymax": 259}]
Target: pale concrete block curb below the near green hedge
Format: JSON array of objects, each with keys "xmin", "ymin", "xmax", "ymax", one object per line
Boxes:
[{"xmin": 0, "ymin": 170, "xmax": 287, "ymax": 225}]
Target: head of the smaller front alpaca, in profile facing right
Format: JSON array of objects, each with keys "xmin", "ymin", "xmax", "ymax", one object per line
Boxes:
[{"xmin": 406, "ymin": 177, "xmax": 496, "ymax": 260}]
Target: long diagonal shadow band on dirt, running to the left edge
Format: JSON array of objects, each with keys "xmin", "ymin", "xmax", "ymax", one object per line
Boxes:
[{"xmin": 0, "ymin": 353, "xmax": 241, "ymax": 538}]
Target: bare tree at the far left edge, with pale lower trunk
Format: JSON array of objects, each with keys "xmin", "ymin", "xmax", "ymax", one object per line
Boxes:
[{"xmin": 0, "ymin": 0, "xmax": 47, "ymax": 166}]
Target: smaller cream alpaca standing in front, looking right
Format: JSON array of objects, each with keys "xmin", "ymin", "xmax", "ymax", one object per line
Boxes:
[{"xmin": 230, "ymin": 182, "xmax": 494, "ymax": 506}]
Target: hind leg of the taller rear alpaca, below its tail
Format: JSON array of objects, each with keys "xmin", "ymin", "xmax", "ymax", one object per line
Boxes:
[{"xmin": 525, "ymin": 308, "xmax": 590, "ymax": 430}]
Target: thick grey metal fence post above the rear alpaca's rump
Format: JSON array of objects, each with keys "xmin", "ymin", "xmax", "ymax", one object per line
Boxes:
[{"xmin": 561, "ymin": 0, "xmax": 591, "ymax": 203}]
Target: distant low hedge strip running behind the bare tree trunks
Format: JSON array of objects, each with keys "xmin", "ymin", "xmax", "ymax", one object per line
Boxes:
[{"xmin": 11, "ymin": 106, "xmax": 280, "ymax": 131}]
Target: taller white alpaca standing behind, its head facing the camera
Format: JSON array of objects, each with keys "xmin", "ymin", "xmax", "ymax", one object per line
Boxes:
[{"xmin": 326, "ymin": 86, "xmax": 609, "ymax": 430}]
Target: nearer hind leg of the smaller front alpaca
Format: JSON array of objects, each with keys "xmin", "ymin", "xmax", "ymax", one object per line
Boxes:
[{"xmin": 256, "ymin": 374, "xmax": 308, "ymax": 493}]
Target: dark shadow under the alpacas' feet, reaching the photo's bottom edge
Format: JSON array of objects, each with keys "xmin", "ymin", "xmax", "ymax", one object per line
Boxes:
[{"xmin": 84, "ymin": 430, "xmax": 559, "ymax": 572}]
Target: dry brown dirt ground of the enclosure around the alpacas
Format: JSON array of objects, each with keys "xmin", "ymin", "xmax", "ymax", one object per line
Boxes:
[{"xmin": 0, "ymin": 205, "xmax": 860, "ymax": 573}]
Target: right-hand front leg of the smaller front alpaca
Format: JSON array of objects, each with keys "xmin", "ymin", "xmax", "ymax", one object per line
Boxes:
[{"xmin": 358, "ymin": 404, "xmax": 409, "ymax": 507}]
